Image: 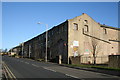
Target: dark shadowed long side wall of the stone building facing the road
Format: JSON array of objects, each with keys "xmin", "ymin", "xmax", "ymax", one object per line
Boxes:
[{"xmin": 23, "ymin": 21, "xmax": 68, "ymax": 63}]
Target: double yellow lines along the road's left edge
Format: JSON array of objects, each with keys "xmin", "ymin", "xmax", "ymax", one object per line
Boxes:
[{"xmin": 2, "ymin": 62, "xmax": 17, "ymax": 80}]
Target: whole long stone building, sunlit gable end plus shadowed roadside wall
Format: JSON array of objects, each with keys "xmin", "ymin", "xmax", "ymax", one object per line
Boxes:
[{"xmin": 11, "ymin": 13, "xmax": 120, "ymax": 64}]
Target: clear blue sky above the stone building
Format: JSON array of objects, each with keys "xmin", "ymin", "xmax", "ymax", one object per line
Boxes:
[{"xmin": 0, "ymin": 2, "xmax": 118, "ymax": 49}]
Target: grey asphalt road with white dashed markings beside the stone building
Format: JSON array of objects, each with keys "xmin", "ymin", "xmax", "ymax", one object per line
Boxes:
[{"xmin": 2, "ymin": 56, "xmax": 120, "ymax": 80}]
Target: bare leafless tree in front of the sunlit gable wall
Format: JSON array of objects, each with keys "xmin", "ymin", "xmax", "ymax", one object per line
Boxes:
[{"xmin": 91, "ymin": 38, "xmax": 100, "ymax": 65}]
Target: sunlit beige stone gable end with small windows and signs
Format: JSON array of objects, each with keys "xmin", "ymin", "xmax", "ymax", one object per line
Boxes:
[{"xmin": 68, "ymin": 13, "xmax": 120, "ymax": 64}]
